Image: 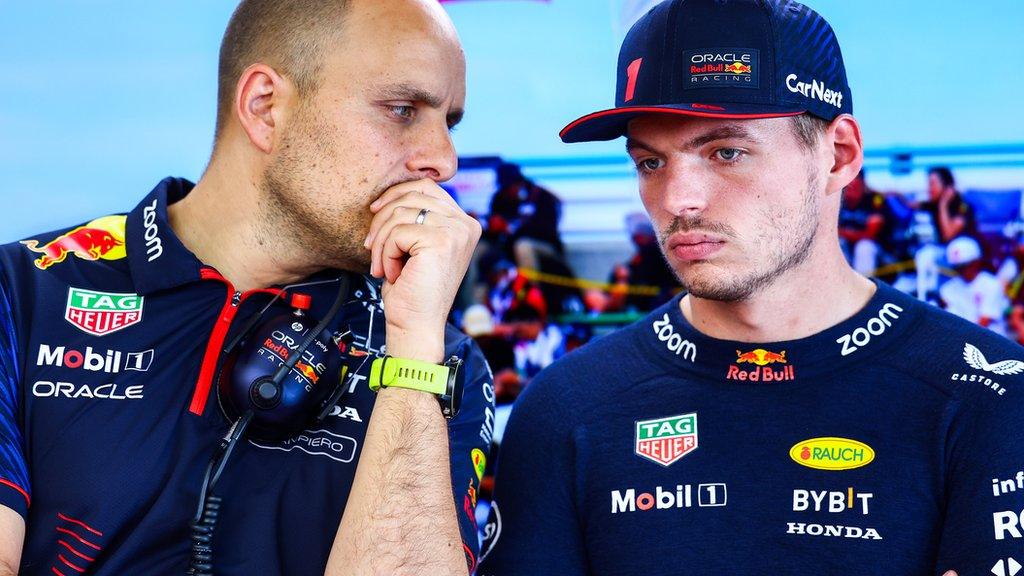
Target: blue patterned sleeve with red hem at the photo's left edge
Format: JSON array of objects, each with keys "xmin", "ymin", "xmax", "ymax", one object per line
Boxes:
[{"xmin": 0, "ymin": 270, "xmax": 30, "ymax": 518}]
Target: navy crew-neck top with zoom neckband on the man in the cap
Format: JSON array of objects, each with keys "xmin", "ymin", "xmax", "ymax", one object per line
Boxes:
[{"xmin": 479, "ymin": 276, "xmax": 1024, "ymax": 576}]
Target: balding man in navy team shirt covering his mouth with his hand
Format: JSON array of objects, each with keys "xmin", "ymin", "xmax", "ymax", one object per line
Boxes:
[{"xmin": 0, "ymin": 0, "xmax": 494, "ymax": 575}]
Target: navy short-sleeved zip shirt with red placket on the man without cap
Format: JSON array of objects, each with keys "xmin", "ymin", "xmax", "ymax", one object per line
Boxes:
[{"xmin": 0, "ymin": 178, "xmax": 494, "ymax": 576}]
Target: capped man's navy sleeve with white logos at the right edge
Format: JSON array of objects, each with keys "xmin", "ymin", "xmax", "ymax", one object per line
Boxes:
[{"xmin": 935, "ymin": 364, "xmax": 1024, "ymax": 576}]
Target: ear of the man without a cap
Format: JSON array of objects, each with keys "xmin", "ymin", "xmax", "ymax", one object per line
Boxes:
[{"xmin": 234, "ymin": 64, "xmax": 295, "ymax": 154}]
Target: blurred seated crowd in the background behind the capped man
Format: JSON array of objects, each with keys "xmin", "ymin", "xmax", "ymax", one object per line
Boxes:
[{"xmin": 453, "ymin": 163, "xmax": 1024, "ymax": 516}]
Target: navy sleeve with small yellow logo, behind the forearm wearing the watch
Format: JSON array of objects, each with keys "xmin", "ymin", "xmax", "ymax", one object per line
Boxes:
[{"xmin": 449, "ymin": 328, "xmax": 495, "ymax": 573}]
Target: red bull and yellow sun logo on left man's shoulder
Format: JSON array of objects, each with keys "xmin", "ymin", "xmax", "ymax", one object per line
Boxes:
[{"xmin": 22, "ymin": 215, "xmax": 127, "ymax": 270}]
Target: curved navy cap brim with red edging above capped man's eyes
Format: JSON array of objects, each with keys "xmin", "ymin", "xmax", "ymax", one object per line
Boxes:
[{"xmin": 558, "ymin": 104, "xmax": 807, "ymax": 143}]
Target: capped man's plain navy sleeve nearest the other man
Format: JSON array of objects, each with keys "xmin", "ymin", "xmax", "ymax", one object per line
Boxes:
[{"xmin": 479, "ymin": 370, "xmax": 588, "ymax": 576}]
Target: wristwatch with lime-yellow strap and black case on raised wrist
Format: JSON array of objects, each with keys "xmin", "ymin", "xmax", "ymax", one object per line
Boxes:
[{"xmin": 370, "ymin": 356, "xmax": 464, "ymax": 420}]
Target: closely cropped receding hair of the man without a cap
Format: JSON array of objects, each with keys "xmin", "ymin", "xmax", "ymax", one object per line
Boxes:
[{"xmin": 216, "ymin": 0, "xmax": 350, "ymax": 138}]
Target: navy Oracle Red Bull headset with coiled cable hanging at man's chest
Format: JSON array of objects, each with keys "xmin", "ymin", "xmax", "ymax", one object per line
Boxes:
[{"xmin": 186, "ymin": 273, "xmax": 369, "ymax": 576}]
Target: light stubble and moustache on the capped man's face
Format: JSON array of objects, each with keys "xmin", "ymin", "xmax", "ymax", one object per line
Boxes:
[{"xmin": 660, "ymin": 168, "xmax": 821, "ymax": 302}]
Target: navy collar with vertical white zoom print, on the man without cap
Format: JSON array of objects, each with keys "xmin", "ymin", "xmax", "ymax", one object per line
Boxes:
[{"xmin": 125, "ymin": 177, "xmax": 203, "ymax": 295}]
